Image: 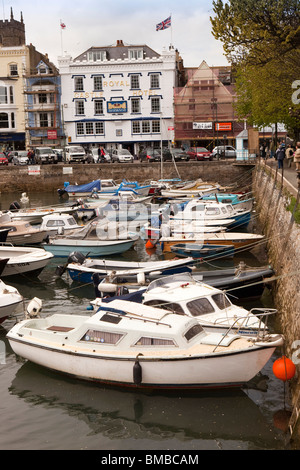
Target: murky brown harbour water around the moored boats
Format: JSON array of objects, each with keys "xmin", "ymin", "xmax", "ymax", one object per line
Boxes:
[{"xmin": 0, "ymin": 194, "xmax": 290, "ymax": 452}]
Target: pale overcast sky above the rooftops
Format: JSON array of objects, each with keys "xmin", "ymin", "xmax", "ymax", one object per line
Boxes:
[{"xmin": 4, "ymin": 0, "xmax": 227, "ymax": 67}]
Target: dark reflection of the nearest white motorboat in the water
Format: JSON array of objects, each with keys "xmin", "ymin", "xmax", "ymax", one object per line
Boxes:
[{"xmin": 9, "ymin": 362, "xmax": 288, "ymax": 449}]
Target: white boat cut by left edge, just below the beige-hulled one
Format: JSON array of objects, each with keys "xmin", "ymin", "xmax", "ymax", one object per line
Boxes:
[{"xmin": 0, "ymin": 245, "xmax": 53, "ymax": 277}]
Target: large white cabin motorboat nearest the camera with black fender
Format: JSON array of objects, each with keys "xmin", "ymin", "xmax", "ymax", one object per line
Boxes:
[{"xmin": 7, "ymin": 300, "xmax": 283, "ymax": 390}]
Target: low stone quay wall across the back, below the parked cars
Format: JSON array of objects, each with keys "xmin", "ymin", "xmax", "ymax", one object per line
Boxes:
[{"xmin": 0, "ymin": 161, "xmax": 254, "ymax": 193}]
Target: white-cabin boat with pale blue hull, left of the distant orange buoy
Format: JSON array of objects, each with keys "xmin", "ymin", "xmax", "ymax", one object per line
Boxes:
[{"xmin": 43, "ymin": 217, "xmax": 139, "ymax": 258}]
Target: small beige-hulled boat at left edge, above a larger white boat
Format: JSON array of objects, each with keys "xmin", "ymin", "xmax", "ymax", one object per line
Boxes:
[{"xmin": 0, "ymin": 212, "xmax": 47, "ymax": 245}]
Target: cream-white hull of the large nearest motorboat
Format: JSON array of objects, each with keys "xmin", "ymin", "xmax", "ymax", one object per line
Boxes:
[{"xmin": 8, "ymin": 333, "xmax": 276, "ymax": 389}]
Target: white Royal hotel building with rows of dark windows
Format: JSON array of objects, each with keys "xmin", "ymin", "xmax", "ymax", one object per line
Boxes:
[{"xmin": 58, "ymin": 41, "xmax": 177, "ymax": 155}]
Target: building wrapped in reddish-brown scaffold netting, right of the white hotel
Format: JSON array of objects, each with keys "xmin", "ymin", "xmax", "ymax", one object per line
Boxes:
[{"xmin": 174, "ymin": 61, "xmax": 244, "ymax": 150}]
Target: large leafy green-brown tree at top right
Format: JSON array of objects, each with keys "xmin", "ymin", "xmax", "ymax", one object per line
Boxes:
[{"xmin": 211, "ymin": 0, "xmax": 300, "ymax": 134}]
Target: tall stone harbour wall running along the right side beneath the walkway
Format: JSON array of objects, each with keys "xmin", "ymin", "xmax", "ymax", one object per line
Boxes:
[{"xmin": 253, "ymin": 166, "xmax": 300, "ymax": 440}]
